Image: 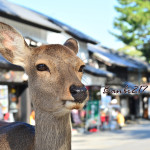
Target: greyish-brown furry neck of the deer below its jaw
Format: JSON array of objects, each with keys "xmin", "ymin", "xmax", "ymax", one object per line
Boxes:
[{"xmin": 35, "ymin": 110, "xmax": 71, "ymax": 150}]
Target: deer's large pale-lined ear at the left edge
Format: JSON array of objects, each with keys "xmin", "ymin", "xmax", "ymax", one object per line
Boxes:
[{"xmin": 0, "ymin": 22, "xmax": 30, "ymax": 67}]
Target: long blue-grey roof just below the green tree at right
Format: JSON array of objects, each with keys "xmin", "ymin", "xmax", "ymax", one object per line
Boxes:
[{"xmin": 88, "ymin": 44, "xmax": 149, "ymax": 70}]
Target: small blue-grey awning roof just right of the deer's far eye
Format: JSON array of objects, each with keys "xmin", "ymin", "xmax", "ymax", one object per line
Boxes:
[{"xmin": 84, "ymin": 65, "xmax": 115, "ymax": 78}]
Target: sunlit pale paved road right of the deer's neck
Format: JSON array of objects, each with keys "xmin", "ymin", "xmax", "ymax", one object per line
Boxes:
[{"xmin": 72, "ymin": 121, "xmax": 150, "ymax": 150}]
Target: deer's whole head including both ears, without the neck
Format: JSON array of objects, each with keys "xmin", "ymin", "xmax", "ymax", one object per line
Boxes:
[{"xmin": 0, "ymin": 23, "xmax": 88, "ymax": 112}]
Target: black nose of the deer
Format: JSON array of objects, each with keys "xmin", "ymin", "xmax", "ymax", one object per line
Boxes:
[{"xmin": 70, "ymin": 85, "xmax": 87, "ymax": 103}]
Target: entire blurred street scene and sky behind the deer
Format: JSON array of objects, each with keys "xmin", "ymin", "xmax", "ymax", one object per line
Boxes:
[{"xmin": 0, "ymin": 0, "xmax": 150, "ymax": 150}]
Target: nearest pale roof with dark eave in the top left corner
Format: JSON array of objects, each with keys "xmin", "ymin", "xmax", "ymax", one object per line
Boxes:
[{"xmin": 0, "ymin": 0, "xmax": 62, "ymax": 32}]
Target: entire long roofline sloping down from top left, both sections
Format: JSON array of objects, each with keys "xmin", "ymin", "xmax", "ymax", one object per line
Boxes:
[{"xmin": 0, "ymin": 0, "xmax": 99, "ymax": 44}]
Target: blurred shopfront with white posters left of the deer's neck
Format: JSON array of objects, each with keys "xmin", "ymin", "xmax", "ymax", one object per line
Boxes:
[{"xmin": 0, "ymin": 56, "xmax": 28, "ymax": 121}]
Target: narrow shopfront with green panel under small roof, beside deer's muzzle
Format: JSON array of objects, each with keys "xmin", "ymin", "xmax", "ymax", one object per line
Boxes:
[{"xmin": 82, "ymin": 65, "xmax": 115, "ymax": 131}]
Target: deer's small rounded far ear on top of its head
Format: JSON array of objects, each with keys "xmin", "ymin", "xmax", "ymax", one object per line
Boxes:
[{"xmin": 64, "ymin": 38, "xmax": 79, "ymax": 54}]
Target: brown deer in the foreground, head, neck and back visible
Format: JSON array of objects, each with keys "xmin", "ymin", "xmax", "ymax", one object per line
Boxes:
[{"xmin": 0, "ymin": 22, "xmax": 89, "ymax": 150}]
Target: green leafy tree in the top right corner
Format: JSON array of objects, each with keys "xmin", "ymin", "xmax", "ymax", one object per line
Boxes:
[{"xmin": 112, "ymin": 0, "xmax": 150, "ymax": 62}]
